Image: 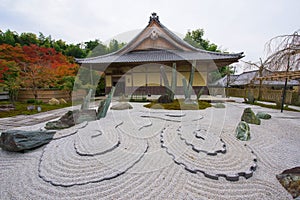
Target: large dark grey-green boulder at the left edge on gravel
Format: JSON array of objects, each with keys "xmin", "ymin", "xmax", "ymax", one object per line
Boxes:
[{"xmin": 0, "ymin": 130, "xmax": 55, "ymax": 151}]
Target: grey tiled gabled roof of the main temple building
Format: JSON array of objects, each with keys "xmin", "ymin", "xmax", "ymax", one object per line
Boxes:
[{"xmin": 77, "ymin": 13, "xmax": 243, "ymax": 66}]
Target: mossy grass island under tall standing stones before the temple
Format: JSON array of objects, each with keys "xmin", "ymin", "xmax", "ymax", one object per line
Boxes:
[{"xmin": 144, "ymin": 99, "xmax": 211, "ymax": 110}]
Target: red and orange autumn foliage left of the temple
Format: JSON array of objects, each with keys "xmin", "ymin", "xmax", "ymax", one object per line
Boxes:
[{"xmin": 0, "ymin": 44, "xmax": 78, "ymax": 100}]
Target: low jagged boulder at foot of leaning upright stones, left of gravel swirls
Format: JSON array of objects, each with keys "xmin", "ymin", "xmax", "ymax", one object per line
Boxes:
[{"xmin": 45, "ymin": 110, "xmax": 96, "ymax": 130}]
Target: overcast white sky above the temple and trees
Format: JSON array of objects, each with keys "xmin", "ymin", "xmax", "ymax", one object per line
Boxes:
[{"xmin": 0, "ymin": 0, "xmax": 300, "ymax": 72}]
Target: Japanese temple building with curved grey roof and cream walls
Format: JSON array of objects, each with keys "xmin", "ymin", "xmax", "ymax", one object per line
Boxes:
[{"xmin": 77, "ymin": 13, "xmax": 243, "ymax": 95}]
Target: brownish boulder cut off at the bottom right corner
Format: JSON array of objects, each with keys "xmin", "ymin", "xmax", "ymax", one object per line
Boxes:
[{"xmin": 276, "ymin": 167, "xmax": 300, "ymax": 198}]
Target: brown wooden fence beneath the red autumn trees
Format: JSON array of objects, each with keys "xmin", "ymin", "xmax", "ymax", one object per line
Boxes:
[{"xmin": 17, "ymin": 89, "xmax": 86, "ymax": 103}]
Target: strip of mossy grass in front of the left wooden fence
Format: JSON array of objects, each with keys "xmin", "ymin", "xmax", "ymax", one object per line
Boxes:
[{"xmin": 0, "ymin": 101, "xmax": 72, "ymax": 118}]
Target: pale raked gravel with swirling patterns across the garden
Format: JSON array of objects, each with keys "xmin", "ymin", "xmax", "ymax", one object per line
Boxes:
[{"xmin": 0, "ymin": 103, "xmax": 300, "ymax": 199}]
